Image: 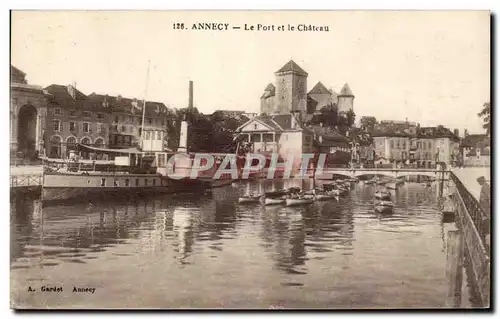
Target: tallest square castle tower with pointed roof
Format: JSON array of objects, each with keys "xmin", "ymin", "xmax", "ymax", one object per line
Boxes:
[{"xmin": 275, "ymin": 60, "xmax": 308, "ymax": 114}]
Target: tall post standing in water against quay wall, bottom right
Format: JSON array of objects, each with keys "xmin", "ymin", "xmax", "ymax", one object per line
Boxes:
[{"xmin": 446, "ymin": 230, "xmax": 464, "ymax": 308}]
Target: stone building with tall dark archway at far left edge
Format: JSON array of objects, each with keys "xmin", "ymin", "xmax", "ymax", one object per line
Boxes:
[{"xmin": 10, "ymin": 65, "xmax": 47, "ymax": 158}]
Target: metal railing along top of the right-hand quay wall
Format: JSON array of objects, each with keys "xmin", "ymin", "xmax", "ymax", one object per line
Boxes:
[{"xmin": 450, "ymin": 173, "xmax": 490, "ymax": 247}]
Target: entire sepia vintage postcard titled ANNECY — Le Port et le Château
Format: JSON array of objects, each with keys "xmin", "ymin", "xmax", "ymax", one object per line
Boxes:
[{"xmin": 10, "ymin": 11, "xmax": 491, "ymax": 310}]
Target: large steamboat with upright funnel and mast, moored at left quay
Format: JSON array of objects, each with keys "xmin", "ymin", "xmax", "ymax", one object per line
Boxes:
[{"xmin": 42, "ymin": 82, "xmax": 235, "ymax": 205}]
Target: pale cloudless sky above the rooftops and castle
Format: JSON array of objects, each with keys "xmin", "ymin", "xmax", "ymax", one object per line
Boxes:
[{"xmin": 11, "ymin": 11, "xmax": 490, "ymax": 133}]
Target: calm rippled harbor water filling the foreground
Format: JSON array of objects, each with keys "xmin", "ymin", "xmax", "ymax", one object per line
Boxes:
[{"xmin": 11, "ymin": 181, "xmax": 473, "ymax": 308}]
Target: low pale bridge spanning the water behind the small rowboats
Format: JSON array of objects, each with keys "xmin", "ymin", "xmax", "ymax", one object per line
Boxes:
[{"xmin": 316, "ymin": 168, "xmax": 450, "ymax": 180}]
